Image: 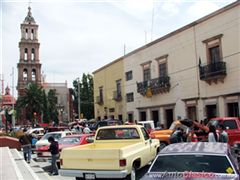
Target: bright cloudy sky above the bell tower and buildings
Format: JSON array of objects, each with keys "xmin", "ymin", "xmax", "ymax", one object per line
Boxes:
[{"xmin": 0, "ymin": 0, "xmax": 236, "ymax": 97}]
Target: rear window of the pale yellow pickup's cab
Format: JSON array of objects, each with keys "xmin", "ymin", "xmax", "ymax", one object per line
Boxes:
[{"xmin": 96, "ymin": 128, "xmax": 140, "ymax": 140}]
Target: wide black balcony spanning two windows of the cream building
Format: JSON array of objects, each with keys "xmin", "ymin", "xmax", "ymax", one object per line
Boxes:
[{"xmin": 137, "ymin": 76, "xmax": 171, "ymax": 97}]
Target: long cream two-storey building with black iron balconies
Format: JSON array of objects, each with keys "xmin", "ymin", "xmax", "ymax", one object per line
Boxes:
[{"xmin": 94, "ymin": 1, "xmax": 240, "ymax": 127}]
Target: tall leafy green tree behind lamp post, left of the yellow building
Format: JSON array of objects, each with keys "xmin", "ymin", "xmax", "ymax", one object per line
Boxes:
[{"xmin": 73, "ymin": 73, "xmax": 94, "ymax": 119}]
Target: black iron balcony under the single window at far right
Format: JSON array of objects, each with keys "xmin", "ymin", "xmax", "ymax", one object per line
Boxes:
[{"xmin": 199, "ymin": 61, "xmax": 227, "ymax": 84}]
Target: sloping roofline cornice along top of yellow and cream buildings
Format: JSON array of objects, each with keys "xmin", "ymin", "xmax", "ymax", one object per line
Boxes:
[{"xmin": 93, "ymin": 0, "xmax": 240, "ymax": 74}]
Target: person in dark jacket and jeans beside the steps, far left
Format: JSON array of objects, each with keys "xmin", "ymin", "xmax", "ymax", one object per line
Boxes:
[{"xmin": 19, "ymin": 129, "xmax": 32, "ymax": 163}]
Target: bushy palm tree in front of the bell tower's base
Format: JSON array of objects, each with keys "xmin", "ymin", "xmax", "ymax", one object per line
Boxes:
[{"xmin": 16, "ymin": 83, "xmax": 43, "ymax": 124}]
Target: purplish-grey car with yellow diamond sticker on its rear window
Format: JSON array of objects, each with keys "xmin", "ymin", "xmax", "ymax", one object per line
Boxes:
[{"xmin": 142, "ymin": 142, "xmax": 239, "ymax": 180}]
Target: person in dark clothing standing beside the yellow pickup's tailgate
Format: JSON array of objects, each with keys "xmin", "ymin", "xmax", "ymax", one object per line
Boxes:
[{"xmin": 48, "ymin": 136, "xmax": 59, "ymax": 176}]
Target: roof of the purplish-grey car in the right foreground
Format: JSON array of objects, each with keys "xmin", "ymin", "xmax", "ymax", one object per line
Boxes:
[{"xmin": 159, "ymin": 142, "xmax": 228, "ymax": 155}]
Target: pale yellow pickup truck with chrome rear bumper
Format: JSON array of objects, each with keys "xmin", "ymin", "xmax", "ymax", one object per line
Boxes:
[{"xmin": 59, "ymin": 125, "xmax": 159, "ymax": 180}]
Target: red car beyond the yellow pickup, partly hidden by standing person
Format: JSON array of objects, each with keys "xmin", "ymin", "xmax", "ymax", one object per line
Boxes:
[{"xmin": 37, "ymin": 134, "xmax": 94, "ymax": 161}]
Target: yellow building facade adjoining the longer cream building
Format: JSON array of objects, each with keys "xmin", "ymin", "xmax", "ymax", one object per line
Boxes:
[{"xmin": 93, "ymin": 58, "xmax": 126, "ymax": 121}]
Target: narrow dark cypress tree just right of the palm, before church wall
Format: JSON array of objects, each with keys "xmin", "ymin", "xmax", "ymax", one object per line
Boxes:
[{"xmin": 48, "ymin": 89, "xmax": 59, "ymax": 124}]
